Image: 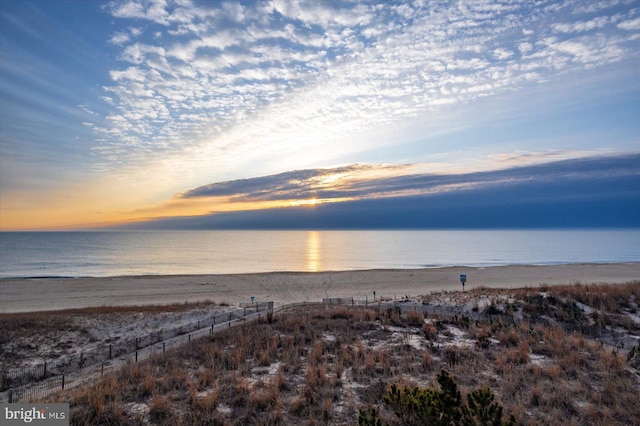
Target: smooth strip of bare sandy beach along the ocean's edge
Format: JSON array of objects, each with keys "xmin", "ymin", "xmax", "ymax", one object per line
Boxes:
[{"xmin": 0, "ymin": 262, "xmax": 640, "ymax": 313}]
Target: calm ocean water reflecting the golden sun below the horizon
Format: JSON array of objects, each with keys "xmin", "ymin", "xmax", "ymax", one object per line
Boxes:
[{"xmin": 0, "ymin": 229, "xmax": 640, "ymax": 278}]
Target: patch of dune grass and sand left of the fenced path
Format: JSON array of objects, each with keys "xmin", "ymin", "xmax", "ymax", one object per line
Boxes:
[{"xmin": 0, "ymin": 301, "xmax": 226, "ymax": 370}]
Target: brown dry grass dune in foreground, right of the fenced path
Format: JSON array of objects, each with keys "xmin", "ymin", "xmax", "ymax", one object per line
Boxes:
[{"xmin": 42, "ymin": 283, "xmax": 640, "ymax": 425}]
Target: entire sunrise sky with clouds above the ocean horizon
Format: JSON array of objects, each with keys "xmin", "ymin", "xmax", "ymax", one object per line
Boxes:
[{"xmin": 0, "ymin": 0, "xmax": 640, "ymax": 231}]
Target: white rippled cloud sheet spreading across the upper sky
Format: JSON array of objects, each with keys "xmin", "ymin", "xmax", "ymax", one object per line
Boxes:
[{"xmin": 96, "ymin": 0, "xmax": 640, "ymax": 176}]
